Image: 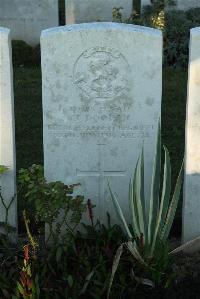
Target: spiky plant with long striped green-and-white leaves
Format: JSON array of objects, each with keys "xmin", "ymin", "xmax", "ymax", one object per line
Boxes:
[{"xmin": 108, "ymin": 124, "xmax": 183, "ymax": 296}]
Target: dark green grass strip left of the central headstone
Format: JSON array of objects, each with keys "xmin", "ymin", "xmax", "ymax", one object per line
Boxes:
[{"xmin": 14, "ymin": 68, "xmax": 43, "ymax": 169}]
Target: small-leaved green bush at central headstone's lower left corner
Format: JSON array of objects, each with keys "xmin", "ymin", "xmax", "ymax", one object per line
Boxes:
[{"xmin": 18, "ymin": 164, "xmax": 86, "ymax": 244}]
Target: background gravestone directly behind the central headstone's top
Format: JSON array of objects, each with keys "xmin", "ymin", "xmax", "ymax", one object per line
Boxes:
[{"xmin": 65, "ymin": 0, "xmax": 133, "ymax": 24}]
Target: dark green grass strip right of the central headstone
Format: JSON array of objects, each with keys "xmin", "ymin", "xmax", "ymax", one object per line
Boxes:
[{"xmin": 162, "ymin": 68, "xmax": 187, "ymax": 181}]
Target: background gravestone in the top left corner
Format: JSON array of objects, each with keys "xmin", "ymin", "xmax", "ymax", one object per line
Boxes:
[{"xmin": 0, "ymin": 0, "xmax": 58, "ymax": 45}]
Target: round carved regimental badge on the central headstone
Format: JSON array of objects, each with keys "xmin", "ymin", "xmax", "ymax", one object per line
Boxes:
[{"xmin": 73, "ymin": 47, "xmax": 129, "ymax": 101}]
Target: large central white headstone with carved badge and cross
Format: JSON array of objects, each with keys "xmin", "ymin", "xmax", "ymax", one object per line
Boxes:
[{"xmin": 41, "ymin": 23, "xmax": 162, "ymax": 222}]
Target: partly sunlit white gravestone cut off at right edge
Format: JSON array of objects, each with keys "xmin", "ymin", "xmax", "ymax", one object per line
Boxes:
[{"xmin": 183, "ymin": 27, "xmax": 200, "ymax": 249}]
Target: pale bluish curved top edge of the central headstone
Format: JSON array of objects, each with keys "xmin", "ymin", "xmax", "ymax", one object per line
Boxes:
[{"xmin": 41, "ymin": 22, "xmax": 162, "ymax": 39}]
